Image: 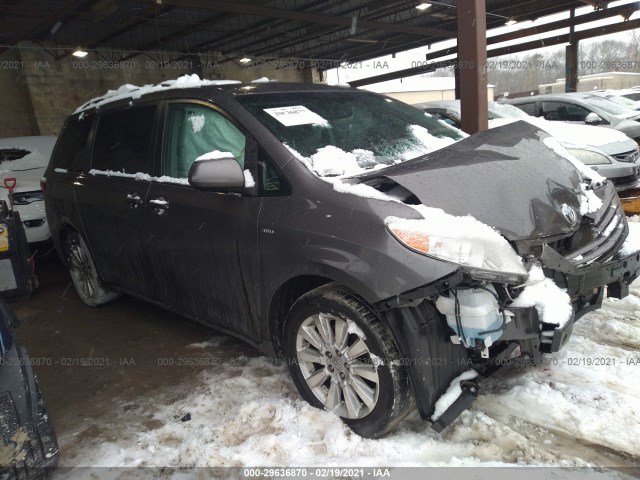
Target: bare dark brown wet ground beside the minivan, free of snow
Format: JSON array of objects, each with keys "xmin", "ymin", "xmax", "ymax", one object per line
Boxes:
[{"xmin": 6, "ymin": 252, "xmax": 258, "ymax": 465}]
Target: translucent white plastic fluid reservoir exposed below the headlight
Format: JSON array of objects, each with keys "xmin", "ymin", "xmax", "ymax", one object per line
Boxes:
[{"xmin": 436, "ymin": 287, "xmax": 509, "ymax": 356}]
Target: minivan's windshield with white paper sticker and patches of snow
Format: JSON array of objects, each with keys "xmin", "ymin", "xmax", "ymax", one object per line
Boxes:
[{"xmin": 238, "ymin": 90, "xmax": 463, "ymax": 177}]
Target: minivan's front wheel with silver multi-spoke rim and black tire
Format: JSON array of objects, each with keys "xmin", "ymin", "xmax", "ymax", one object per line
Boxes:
[{"xmin": 285, "ymin": 284, "xmax": 414, "ymax": 438}]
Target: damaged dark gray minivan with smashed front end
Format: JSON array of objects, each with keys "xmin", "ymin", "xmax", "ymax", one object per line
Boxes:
[{"xmin": 45, "ymin": 77, "xmax": 640, "ymax": 437}]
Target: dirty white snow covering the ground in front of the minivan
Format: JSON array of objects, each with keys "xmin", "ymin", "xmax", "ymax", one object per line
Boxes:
[{"xmin": 60, "ymin": 276, "xmax": 640, "ymax": 470}]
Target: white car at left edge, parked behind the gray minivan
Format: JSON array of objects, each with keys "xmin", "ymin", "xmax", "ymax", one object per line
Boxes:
[{"xmin": 0, "ymin": 136, "xmax": 56, "ymax": 243}]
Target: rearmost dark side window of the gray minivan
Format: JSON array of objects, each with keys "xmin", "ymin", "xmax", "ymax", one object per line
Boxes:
[{"xmin": 51, "ymin": 115, "xmax": 94, "ymax": 172}]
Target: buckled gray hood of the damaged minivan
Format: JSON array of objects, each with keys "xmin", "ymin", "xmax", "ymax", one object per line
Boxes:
[{"xmin": 355, "ymin": 121, "xmax": 583, "ymax": 241}]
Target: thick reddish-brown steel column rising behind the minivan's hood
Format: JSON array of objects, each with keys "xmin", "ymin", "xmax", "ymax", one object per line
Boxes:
[{"xmin": 457, "ymin": 0, "xmax": 488, "ymax": 134}]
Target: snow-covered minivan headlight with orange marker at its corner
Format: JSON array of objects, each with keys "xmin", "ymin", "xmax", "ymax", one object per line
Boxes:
[{"xmin": 385, "ymin": 207, "xmax": 527, "ymax": 282}]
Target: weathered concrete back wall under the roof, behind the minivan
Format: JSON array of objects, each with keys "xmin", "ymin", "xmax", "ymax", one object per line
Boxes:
[{"xmin": 0, "ymin": 44, "xmax": 317, "ymax": 138}]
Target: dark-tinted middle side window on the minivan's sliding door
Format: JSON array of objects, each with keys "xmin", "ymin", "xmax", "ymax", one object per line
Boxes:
[{"xmin": 92, "ymin": 105, "xmax": 156, "ymax": 173}]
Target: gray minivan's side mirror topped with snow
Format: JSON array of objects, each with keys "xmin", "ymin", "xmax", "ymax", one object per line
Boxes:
[{"xmin": 189, "ymin": 158, "xmax": 244, "ymax": 190}]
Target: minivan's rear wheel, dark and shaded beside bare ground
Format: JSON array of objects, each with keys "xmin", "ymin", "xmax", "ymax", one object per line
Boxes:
[{"xmin": 66, "ymin": 232, "xmax": 120, "ymax": 307}]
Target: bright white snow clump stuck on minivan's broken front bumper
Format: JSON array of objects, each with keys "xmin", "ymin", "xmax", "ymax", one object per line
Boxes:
[{"xmin": 510, "ymin": 265, "xmax": 573, "ymax": 327}]
